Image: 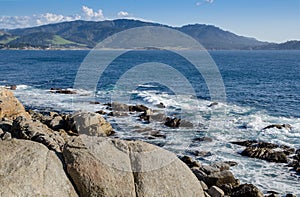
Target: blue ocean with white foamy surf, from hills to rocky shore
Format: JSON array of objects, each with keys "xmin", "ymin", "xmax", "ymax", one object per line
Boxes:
[{"xmin": 0, "ymin": 50, "xmax": 300, "ymax": 195}]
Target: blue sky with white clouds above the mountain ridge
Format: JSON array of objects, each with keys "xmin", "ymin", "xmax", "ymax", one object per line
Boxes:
[{"xmin": 0, "ymin": 0, "xmax": 300, "ymax": 42}]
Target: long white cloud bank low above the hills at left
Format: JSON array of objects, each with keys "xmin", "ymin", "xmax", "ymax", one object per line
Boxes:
[{"xmin": 0, "ymin": 6, "xmax": 106, "ymax": 29}]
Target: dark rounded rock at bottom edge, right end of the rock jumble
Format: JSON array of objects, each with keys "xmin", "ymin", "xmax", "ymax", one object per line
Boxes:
[{"xmin": 231, "ymin": 184, "xmax": 264, "ymax": 197}]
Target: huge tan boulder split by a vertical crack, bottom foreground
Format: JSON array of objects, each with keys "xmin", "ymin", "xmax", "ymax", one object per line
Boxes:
[{"xmin": 63, "ymin": 135, "xmax": 204, "ymax": 196}]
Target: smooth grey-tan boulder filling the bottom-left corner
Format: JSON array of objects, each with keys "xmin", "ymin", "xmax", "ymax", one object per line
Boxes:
[{"xmin": 0, "ymin": 139, "xmax": 78, "ymax": 197}]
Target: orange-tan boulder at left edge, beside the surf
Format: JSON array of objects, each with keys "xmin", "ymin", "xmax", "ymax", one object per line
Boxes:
[{"xmin": 0, "ymin": 88, "xmax": 30, "ymax": 120}]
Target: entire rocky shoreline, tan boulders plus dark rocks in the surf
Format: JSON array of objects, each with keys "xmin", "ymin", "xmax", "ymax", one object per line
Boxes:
[{"xmin": 0, "ymin": 88, "xmax": 300, "ymax": 197}]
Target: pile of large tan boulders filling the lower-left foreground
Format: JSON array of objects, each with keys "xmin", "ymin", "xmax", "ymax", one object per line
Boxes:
[{"xmin": 0, "ymin": 89, "xmax": 204, "ymax": 197}]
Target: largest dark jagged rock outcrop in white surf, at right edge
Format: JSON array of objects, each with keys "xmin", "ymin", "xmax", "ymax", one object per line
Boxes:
[{"xmin": 231, "ymin": 140, "xmax": 300, "ymax": 175}]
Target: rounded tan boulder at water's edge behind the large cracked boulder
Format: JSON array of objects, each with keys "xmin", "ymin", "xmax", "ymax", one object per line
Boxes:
[{"xmin": 70, "ymin": 112, "xmax": 113, "ymax": 136}]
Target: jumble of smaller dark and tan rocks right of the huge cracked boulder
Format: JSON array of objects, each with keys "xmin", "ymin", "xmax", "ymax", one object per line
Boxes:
[{"xmin": 180, "ymin": 156, "xmax": 264, "ymax": 197}]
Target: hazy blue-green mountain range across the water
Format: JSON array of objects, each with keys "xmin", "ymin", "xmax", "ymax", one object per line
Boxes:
[{"xmin": 0, "ymin": 19, "xmax": 300, "ymax": 50}]
